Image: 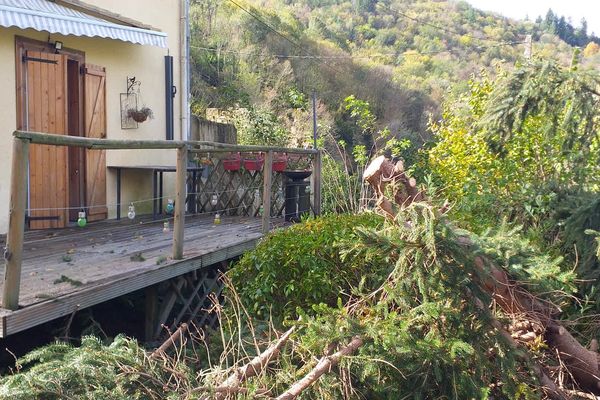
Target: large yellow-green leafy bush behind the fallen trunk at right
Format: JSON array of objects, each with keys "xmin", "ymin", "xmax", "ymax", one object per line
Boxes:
[{"xmin": 428, "ymin": 63, "xmax": 600, "ymax": 230}]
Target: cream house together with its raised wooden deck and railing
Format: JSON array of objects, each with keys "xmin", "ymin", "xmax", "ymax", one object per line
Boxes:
[{"xmin": 0, "ymin": 0, "xmax": 321, "ymax": 334}]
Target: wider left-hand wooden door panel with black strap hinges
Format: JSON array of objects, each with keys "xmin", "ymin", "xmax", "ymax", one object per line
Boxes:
[{"xmin": 23, "ymin": 51, "xmax": 69, "ymax": 229}]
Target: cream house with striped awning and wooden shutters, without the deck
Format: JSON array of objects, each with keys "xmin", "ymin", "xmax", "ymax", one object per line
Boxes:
[{"xmin": 0, "ymin": 0, "xmax": 189, "ymax": 233}]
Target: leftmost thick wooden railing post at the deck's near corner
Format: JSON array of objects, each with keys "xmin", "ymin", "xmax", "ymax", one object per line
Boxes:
[{"xmin": 2, "ymin": 139, "xmax": 29, "ymax": 310}]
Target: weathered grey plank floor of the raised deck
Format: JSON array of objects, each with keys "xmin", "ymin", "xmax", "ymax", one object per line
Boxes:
[{"xmin": 0, "ymin": 216, "xmax": 279, "ymax": 337}]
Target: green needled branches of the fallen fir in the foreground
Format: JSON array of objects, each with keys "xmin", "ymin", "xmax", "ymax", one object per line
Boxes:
[{"xmin": 0, "ymin": 208, "xmax": 592, "ymax": 400}]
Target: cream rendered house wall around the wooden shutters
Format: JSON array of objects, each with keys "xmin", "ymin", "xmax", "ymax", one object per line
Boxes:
[{"xmin": 0, "ymin": 0, "xmax": 182, "ymax": 233}]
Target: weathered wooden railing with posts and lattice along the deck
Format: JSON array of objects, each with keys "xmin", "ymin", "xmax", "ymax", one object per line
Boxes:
[{"xmin": 2, "ymin": 131, "xmax": 321, "ymax": 310}]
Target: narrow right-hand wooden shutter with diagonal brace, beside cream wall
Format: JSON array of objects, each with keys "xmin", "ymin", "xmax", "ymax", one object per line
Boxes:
[{"xmin": 83, "ymin": 64, "xmax": 108, "ymax": 221}]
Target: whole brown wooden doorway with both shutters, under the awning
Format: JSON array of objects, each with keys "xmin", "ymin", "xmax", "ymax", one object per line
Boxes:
[{"xmin": 17, "ymin": 38, "xmax": 108, "ymax": 229}]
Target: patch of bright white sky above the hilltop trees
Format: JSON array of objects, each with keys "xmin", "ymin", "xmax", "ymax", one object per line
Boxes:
[{"xmin": 467, "ymin": 0, "xmax": 600, "ymax": 36}]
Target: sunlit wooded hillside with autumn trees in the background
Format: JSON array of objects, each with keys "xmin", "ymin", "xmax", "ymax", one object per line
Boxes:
[{"xmin": 192, "ymin": 0, "xmax": 598, "ymax": 150}]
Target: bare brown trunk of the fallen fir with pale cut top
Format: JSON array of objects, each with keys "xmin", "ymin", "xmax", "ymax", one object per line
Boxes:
[{"xmin": 364, "ymin": 157, "xmax": 600, "ymax": 398}]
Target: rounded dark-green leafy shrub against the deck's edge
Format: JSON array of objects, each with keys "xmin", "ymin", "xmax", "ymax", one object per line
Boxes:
[{"xmin": 229, "ymin": 214, "xmax": 383, "ymax": 320}]
